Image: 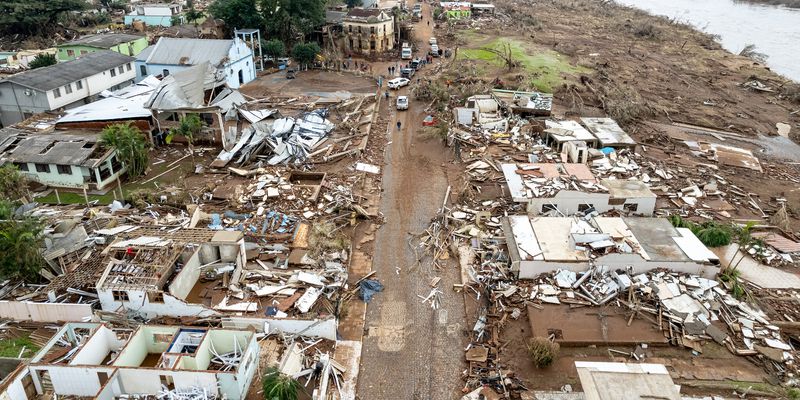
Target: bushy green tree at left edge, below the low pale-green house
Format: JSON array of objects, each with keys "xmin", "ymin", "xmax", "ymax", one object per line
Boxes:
[{"xmin": 0, "ymin": 208, "xmax": 45, "ymax": 282}]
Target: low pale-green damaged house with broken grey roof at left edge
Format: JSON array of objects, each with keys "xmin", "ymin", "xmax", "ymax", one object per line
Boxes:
[{"xmin": 0, "ymin": 128, "xmax": 126, "ymax": 191}]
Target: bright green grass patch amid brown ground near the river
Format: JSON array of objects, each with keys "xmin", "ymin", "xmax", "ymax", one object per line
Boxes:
[{"xmin": 458, "ymin": 38, "xmax": 588, "ymax": 93}]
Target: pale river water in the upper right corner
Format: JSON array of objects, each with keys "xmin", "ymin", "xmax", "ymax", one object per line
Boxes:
[{"xmin": 616, "ymin": 0, "xmax": 800, "ymax": 82}]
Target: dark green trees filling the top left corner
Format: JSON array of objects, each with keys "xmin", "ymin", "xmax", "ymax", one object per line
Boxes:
[{"xmin": 0, "ymin": 0, "xmax": 86, "ymax": 35}]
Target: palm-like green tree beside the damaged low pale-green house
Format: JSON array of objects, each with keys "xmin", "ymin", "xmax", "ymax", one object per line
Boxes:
[{"xmin": 100, "ymin": 123, "xmax": 150, "ymax": 178}]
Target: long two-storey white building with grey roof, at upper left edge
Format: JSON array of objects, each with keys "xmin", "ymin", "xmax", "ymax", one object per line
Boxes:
[{"xmin": 0, "ymin": 50, "xmax": 136, "ymax": 126}]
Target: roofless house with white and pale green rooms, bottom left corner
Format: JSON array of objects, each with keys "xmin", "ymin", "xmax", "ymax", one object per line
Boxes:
[{"xmin": 0, "ymin": 323, "xmax": 259, "ymax": 400}]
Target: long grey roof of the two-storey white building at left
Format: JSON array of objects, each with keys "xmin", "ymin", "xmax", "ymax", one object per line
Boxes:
[{"xmin": 0, "ymin": 50, "xmax": 134, "ymax": 91}]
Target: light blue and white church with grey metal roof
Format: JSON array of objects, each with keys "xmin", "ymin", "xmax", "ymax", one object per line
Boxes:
[{"xmin": 136, "ymin": 37, "xmax": 256, "ymax": 89}]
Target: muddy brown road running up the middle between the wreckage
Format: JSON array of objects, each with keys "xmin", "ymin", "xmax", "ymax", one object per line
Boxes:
[{"xmin": 357, "ymin": 4, "xmax": 465, "ymax": 399}]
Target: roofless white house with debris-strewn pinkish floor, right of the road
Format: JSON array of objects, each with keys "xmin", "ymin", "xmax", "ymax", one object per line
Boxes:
[{"xmin": 500, "ymin": 163, "xmax": 657, "ymax": 216}]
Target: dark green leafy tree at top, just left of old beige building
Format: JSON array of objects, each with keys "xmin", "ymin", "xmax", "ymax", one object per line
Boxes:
[{"xmin": 259, "ymin": 0, "xmax": 325, "ymax": 42}]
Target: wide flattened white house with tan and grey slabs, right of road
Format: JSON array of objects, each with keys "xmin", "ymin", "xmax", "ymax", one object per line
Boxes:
[{"xmin": 503, "ymin": 215, "xmax": 718, "ymax": 279}]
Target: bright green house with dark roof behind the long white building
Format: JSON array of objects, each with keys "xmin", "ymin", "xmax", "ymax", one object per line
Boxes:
[{"xmin": 57, "ymin": 33, "xmax": 148, "ymax": 61}]
